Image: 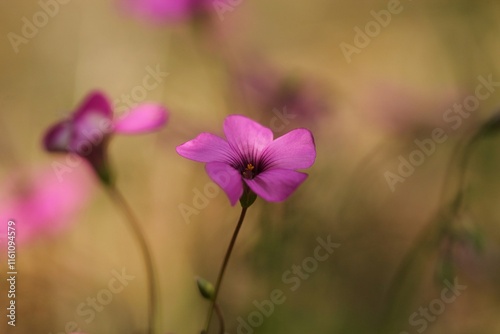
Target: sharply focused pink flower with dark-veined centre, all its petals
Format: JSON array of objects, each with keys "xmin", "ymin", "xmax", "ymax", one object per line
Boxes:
[{"xmin": 177, "ymin": 115, "xmax": 316, "ymax": 205}]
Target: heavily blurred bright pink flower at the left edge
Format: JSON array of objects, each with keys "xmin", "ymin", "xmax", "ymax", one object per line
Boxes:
[{"xmin": 0, "ymin": 163, "xmax": 92, "ymax": 248}]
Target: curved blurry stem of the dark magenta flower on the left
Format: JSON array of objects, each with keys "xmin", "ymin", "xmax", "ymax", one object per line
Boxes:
[{"xmin": 105, "ymin": 185, "xmax": 158, "ymax": 334}]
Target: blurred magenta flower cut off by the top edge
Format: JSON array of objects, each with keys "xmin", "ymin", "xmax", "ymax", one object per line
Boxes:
[{"xmin": 122, "ymin": 0, "xmax": 211, "ymax": 23}]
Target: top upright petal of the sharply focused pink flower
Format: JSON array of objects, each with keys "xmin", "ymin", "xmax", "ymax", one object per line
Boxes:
[{"xmin": 224, "ymin": 115, "xmax": 273, "ymax": 163}]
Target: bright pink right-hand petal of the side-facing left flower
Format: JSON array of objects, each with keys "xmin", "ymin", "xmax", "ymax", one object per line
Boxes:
[{"xmin": 114, "ymin": 104, "xmax": 168, "ymax": 134}]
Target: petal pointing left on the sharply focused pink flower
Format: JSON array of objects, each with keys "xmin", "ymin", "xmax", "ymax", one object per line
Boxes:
[{"xmin": 176, "ymin": 132, "xmax": 234, "ymax": 164}]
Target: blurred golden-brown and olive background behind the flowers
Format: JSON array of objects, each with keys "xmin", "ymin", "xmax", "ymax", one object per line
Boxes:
[{"xmin": 0, "ymin": 0, "xmax": 500, "ymax": 334}]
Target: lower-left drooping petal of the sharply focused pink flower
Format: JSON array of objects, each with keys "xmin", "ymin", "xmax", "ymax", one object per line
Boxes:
[{"xmin": 205, "ymin": 162, "xmax": 243, "ymax": 205}]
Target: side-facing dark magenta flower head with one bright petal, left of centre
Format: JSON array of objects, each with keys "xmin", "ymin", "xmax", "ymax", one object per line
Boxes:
[{"xmin": 44, "ymin": 91, "xmax": 168, "ymax": 183}]
